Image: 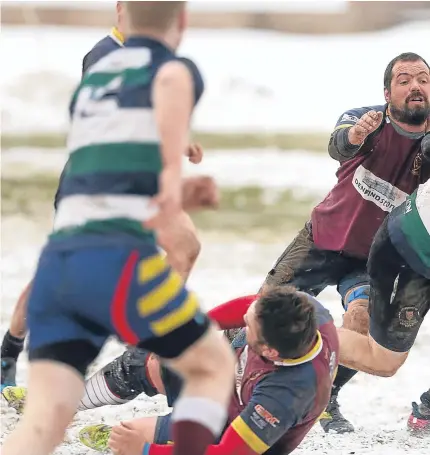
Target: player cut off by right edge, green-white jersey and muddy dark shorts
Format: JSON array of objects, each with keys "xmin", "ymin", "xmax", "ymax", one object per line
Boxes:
[{"xmin": 339, "ymin": 177, "xmax": 430, "ymax": 432}]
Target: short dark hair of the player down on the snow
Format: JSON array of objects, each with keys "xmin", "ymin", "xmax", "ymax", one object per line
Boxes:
[{"xmin": 255, "ymin": 286, "xmax": 317, "ymax": 359}]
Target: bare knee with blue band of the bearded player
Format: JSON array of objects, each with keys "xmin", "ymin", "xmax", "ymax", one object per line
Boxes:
[{"xmin": 343, "ymin": 284, "xmax": 370, "ymax": 334}]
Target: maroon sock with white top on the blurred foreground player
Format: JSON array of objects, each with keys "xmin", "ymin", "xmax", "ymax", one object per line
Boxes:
[{"xmin": 172, "ymin": 396, "xmax": 227, "ymax": 455}]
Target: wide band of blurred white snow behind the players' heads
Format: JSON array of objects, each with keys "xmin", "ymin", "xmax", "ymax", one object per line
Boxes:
[{"xmin": 0, "ymin": 21, "xmax": 430, "ymax": 132}]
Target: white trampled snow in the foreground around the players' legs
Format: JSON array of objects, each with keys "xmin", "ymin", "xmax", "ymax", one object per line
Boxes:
[{"xmin": 1, "ymin": 215, "xmax": 430, "ymax": 455}]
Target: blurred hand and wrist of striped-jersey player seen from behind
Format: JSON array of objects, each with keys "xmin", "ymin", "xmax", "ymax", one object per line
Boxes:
[{"xmin": 144, "ymin": 167, "xmax": 182, "ymax": 229}]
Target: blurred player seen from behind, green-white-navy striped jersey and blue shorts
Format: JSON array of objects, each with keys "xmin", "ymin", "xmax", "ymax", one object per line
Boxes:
[{"xmin": 2, "ymin": 2, "xmax": 234, "ymax": 455}]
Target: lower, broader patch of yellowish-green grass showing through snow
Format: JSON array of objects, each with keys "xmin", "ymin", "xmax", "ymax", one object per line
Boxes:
[{"xmin": 1, "ymin": 175, "xmax": 316, "ymax": 235}]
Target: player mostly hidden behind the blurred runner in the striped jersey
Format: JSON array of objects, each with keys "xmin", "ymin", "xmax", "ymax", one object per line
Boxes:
[{"xmin": 0, "ymin": 2, "xmax": 218, "ymax": 390}]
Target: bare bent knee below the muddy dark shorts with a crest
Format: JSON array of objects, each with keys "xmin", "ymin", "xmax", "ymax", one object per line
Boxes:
[{"xmin": 337, "ymin": 328, "xmax": 407, "ymax": 377}]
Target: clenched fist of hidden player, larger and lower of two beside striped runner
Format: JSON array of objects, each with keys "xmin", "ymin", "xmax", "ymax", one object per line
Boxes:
[{"xmin": 182, "ymin": 176, "xmax": 219, "ymax": 212}]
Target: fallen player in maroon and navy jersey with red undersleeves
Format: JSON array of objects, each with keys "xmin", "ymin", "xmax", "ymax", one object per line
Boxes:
[{"xmin": 75, "ymin": 287, "xmax": 338, "ymax": 455}]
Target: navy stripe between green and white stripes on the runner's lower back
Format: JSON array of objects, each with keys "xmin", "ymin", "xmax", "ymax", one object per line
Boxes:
[{"xmin": 58, "ymin": 171, "xmax": 158, "ymax": 200}]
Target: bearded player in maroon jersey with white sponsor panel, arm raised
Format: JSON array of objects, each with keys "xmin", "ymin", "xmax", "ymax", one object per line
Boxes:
[{"xmin": 256, "ymin": 53, "xmax": 430, "ymax": 433}]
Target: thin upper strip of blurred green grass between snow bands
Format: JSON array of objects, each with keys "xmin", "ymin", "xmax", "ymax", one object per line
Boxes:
[{"xmin": 1, "ymin": 132, "xmax": 329, "ymax": 152}]
